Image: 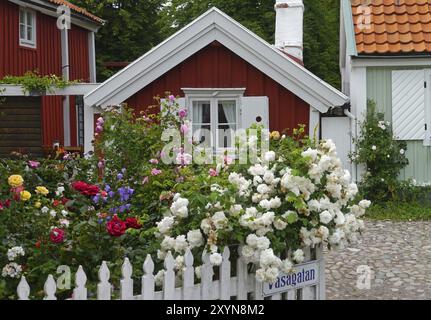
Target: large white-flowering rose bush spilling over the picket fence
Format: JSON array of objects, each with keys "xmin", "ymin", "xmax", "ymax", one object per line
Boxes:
[{"xmin": 156, "ymin": 129, "xmax": 370, "ymax": 282}]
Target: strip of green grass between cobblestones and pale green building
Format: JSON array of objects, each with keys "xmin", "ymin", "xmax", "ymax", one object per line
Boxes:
[{"xmin": 366, "ymin": 202, "xmax": 431, "ymax": 221}]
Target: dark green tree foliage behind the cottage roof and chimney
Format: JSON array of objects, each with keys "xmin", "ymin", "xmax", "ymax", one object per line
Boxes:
[{"xmin": 72, "ymin": 0, "xmax": 340, "ymax": 89}]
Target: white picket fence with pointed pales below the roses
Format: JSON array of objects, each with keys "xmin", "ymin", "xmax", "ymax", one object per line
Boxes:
[{"xmin": 17, "ymin": 247, "xmax": 325, "ymax": 300}]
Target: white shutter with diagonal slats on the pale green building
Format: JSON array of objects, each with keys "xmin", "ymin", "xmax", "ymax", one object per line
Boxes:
[{"xmin": 392, "ymin": 70, "xmax": 426, "ymax": 140}]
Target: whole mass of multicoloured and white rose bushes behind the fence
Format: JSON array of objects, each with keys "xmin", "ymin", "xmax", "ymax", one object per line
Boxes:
[{"xmin": 0, "ymin": 96, "xmax": 370, "ymax": 298}]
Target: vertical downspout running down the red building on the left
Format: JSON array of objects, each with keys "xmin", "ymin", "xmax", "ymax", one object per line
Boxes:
[{"xmin": 61, "ymin": 27, "xmax": 71, "ymax": 146}]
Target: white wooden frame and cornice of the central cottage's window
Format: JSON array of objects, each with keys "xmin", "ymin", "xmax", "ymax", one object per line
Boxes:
[{"xmin": 182, "ymin": 88, "xmax": 246, "ymax": 154}]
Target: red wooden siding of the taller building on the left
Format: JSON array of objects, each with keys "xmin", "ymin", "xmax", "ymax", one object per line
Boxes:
[{"xmin": 0, "ymin": 0, "xmax": 89, "ymax": 146}]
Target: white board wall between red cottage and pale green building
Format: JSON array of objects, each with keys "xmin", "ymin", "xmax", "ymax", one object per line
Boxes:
[{"xmin": 322, "ymin": 117, "xmax": 353, "ymax": 172}]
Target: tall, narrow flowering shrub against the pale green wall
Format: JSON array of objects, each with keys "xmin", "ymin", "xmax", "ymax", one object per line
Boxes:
[{"xmin": 351, "ymin": 101, "xmax": 409, "ymax": 201}]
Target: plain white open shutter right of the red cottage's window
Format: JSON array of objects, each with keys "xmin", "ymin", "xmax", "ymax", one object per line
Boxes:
[{"xmin": 240, "ymin": 97, "xmax": 269, "ymax": 129}]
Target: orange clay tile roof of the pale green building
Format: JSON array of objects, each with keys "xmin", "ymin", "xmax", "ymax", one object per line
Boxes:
[{"xmin": 351, "ymin": 0, "xmax": 431, "ymax": 54}]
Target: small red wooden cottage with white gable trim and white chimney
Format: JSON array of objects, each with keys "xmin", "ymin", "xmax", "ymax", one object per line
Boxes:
[{"xmin": 84, "ymin": 0, "xmax": 349, "ymax": 159}]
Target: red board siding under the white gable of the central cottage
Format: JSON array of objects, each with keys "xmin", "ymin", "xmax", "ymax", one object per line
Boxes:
[{"xmin": 127, "ymin": 43, "xmax": 310, "ymax": 133}]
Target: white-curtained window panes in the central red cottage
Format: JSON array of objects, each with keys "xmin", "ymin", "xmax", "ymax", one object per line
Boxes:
[{"xmin": 189, "ymin": 98, "xmax": 239, "ymax": 152}]
